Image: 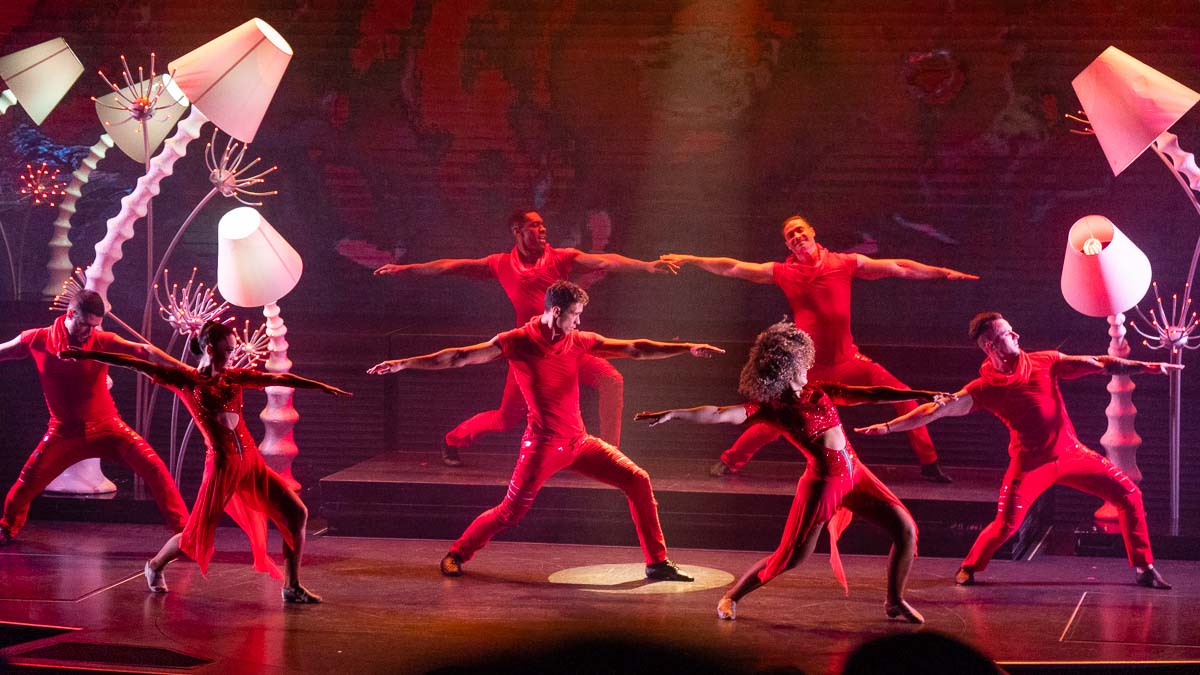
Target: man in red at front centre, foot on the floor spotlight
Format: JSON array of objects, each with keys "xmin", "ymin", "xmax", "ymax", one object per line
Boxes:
[{"xmin": 367, "ymin": 281, "xmax": 725, "ymax": 581}]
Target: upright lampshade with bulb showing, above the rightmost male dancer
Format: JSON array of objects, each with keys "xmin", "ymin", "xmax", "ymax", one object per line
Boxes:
[{"xmin": 1062, "ymin": 215, "xmax": 1151, "ymax": 316}]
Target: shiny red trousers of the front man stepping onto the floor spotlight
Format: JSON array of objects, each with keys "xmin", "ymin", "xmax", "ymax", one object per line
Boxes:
[{"xmin": 450, "ymin": 436, "xmax": 667, "ymax": 565}]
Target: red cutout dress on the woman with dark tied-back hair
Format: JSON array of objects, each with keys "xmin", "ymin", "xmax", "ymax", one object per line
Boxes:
[{"xmin": 151, "ymin": 368, "xmax": 293, "ymax": 579}]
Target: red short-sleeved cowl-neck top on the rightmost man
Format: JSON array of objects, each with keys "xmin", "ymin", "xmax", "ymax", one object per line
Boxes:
[{"xmin": 964, "ymin": 351, "xmax": 1094, "ymax": 465}]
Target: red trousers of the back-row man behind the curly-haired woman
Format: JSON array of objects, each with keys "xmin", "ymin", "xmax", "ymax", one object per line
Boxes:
[{"xmin": 721, "ymin": 353, "xmax": 937, "ymax": 471}]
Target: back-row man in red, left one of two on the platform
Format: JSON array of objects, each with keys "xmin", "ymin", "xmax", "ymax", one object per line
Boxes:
[{"xmin": 376, "ymin": 209, "xmax": 676, "ymax": 466}]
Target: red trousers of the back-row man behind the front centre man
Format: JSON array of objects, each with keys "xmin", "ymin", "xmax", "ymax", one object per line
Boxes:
[{"xmin": 446, "ymin": 357, "xmax": 625, "ymax": 448}]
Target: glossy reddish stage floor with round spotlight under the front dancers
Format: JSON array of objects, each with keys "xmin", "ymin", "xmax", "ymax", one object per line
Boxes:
[{"xmin": 0, "ymin": 521, "xmax": 1200, "ymax": 674}]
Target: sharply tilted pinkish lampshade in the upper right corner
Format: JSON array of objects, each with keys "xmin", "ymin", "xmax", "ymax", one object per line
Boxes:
[{"xmin": 1070, "ymin": 47, "xmax": 1200, "ymax": 175}]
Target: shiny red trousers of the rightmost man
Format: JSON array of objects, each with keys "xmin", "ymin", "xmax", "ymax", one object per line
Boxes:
[{"xmin": 962, "ymin": 444, "xmax": 1154, "ymax": 572}]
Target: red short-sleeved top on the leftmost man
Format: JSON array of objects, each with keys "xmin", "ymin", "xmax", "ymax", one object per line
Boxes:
[{"xmin": 20, "ymin": 315, "xmax": 124, "ymax": 425}]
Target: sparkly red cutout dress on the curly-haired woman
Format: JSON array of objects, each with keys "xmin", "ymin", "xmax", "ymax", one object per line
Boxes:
[{"xmin": 744, "ymin": 384, "xmax": 907, "ymax": 592}]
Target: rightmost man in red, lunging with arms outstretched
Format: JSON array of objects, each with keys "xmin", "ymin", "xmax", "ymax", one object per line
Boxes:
[{"xmin": 857, "ymin": 312, "xmax": 1183, "ymax": 589}]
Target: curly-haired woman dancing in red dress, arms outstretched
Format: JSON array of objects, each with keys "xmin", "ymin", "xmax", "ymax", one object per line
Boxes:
[{"xmin": 635, "ymin": 321, "xmax": 949, "ymax": 623}]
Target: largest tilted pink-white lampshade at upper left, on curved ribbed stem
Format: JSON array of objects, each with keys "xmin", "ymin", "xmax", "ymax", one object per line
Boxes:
[{"xmin": 168, "ymin": 19, "xmax": 292, "ymax": 143}]
